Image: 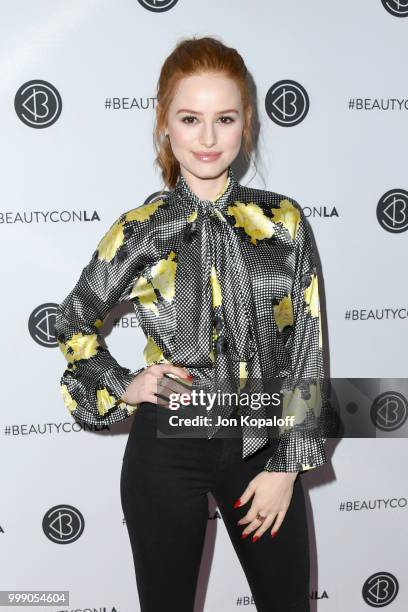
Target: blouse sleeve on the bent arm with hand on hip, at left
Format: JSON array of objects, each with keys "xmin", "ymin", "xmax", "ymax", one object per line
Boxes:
[{"xmin": 55, "ymin": 213, "xmax": 148, "ymax": 425}]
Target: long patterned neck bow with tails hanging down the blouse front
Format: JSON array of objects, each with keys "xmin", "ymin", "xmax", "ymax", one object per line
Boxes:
[{"xmin": 172, "ymin": 167, "xmax": 268, "ymax": 457}]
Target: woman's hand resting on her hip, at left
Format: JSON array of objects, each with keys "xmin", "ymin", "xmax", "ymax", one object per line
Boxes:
[{"xmin": 121, "ymin": 363, "xmax": 193, "ymax": 407}]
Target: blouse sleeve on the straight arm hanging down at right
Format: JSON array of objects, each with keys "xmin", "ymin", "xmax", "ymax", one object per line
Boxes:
[{"xmin": 264, "ymin": 202, "xmax": 330, "ymax": 472}]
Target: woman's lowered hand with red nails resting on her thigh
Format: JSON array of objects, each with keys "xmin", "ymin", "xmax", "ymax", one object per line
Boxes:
[{"xmin": 234, "ymin": 470, "xmax": 298, "ymax": 542}]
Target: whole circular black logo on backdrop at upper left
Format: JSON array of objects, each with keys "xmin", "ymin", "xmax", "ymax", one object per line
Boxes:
[{"xmin": 14, "ymin": 79, "xmax": 62, "ymax": 128}]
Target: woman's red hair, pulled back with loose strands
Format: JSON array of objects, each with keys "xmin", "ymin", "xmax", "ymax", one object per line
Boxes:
[{"xmin": 153, "ymin": 36, "xmax": 254, "ymax": 189}]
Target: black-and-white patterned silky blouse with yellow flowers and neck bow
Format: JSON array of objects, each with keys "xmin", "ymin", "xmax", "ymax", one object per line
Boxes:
[{"xmin": 55, "ymin": 166, "xmax": 330, "ymax": 472}]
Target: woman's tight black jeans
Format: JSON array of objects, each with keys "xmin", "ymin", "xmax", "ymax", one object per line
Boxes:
[{"xmin": 120, "ymin": 402, "xmax": 310, "ymax": 612}]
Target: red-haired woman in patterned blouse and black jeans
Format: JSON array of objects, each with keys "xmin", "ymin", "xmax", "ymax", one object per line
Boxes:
[{"xmin": 56, "ymin": 37, "xmax": 327, "ymax": 612}]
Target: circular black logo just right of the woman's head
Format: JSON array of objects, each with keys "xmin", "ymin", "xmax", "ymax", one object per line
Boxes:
[{"xmin": 265, "ymin": 79, "xmax": 309, "ymax": 127}]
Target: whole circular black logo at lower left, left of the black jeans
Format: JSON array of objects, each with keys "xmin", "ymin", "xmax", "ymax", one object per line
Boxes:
[{"xmin": 42, "ymin": 504, "xmax": 85, "ymax": 544}]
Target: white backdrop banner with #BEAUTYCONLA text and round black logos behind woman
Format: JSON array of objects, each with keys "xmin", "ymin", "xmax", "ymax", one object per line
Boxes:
[{"xmin": 0, "ymin": 0, "xmax": 408, "ymax": 612}]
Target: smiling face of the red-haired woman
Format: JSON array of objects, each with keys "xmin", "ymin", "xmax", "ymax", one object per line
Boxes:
[{"xmin": 166, "ymin": 73, "xmax": 244, "ymax": 179}]
